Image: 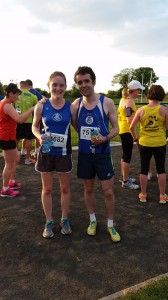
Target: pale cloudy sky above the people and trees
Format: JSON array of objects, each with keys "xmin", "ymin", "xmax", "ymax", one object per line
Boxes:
[{"xmin": 0, "ymin": 0, "xmax": 168, "ymax": 93}]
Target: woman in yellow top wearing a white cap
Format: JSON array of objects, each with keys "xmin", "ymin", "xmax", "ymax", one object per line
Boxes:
[{"xmin": 118, "ymin": 80, "xmax": 145, "ymax": 190}]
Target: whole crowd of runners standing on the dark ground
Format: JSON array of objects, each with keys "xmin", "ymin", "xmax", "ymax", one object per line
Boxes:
[{"xmin": 0, "ymin": 66, "xmax": 168, "ymax": 242}]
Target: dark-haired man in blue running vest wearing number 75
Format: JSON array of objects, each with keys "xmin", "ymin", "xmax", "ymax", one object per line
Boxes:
[{"xmin": 73, "ymin": 66, "xmax": 120, "ymax": 242}]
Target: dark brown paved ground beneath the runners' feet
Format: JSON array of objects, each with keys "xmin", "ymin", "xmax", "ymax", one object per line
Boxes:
[{"xmin": 0, "ymin": 146, "xmax": 168, "ymax": 300}]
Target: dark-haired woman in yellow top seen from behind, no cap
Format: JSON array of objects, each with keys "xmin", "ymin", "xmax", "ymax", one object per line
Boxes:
[{"xmin": 130, "ymin": 85, "xmax": 168, "ymax": 204}]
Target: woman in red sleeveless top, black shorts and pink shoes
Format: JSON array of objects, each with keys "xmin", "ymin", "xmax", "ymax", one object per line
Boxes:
[{"xmin": 0, "ymin": 83, "xmax": 34, "ymax": 197}]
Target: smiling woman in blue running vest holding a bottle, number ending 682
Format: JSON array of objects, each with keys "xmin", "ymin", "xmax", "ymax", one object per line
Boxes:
[{"xmin": 32, "ymin": 71, "xmax": 75, "ymax": 238}]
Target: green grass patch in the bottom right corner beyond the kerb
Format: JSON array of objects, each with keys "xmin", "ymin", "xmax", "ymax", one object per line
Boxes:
[{"xmin": 116, "ymin": 277, "xmax": 168, "ymax": 300}]
